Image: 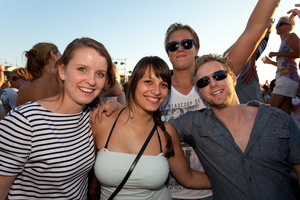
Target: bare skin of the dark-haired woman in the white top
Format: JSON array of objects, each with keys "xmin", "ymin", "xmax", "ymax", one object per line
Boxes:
[{"xmin": 92, "ymin": 68, "xmax": 210, "ymax": 198}]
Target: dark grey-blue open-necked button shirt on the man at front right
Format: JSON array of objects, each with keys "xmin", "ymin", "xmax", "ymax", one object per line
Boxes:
[{"xmin": 169, "ymin": 104, "xmax": 300, "ymax": 200}]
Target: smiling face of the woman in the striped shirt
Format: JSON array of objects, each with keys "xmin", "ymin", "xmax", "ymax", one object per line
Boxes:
[{"xmin": 58, "ymin": 47, "xmax": 108, "ymax": 110}]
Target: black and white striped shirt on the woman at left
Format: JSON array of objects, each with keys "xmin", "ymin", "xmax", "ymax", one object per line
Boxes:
[{"xmin": 0, "ymin": 102, "xmax": 94, "ymax": 199}]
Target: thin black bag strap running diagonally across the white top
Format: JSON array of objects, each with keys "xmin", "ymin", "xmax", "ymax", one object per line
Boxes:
[{"xmin": 108, "ymin": 124, "xmax": 156, "ymax": 200}]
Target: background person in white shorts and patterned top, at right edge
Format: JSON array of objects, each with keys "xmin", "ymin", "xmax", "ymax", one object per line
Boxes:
[{"xmin": 262, "ymin": 16, "xmax": 300, "ymax": 114}]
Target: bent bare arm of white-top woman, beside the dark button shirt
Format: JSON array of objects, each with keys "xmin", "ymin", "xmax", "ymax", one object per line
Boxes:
[{"xmin": 165, "ymin": 123, "xmax": 211, "ymax": 189}]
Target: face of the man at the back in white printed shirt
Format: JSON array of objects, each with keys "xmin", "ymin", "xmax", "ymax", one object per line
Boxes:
[{"xmin": 168, "ymin": 29, "xmax": 199, "ymax": 70}]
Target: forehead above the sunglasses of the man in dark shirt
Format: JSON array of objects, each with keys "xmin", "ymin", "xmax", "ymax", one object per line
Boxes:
[{"xmin": 196, "ymin": 61, "xmax": 227, "ymax": 79}]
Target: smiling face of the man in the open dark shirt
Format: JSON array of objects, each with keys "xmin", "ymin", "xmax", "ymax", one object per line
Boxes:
[{"xmin": 196, "ymin": 61, "xmax": 238, "ymax": 109}]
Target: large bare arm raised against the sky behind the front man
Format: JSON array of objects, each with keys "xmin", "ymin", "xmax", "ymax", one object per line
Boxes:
[{"xmin": 228, "ymin": 0, "xmax": 280, "ymax": 75}]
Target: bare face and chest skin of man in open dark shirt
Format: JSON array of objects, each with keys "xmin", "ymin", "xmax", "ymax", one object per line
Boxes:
[{"xmin": 196, "ymin": 62, "xmax": 300, "ymax": 186}]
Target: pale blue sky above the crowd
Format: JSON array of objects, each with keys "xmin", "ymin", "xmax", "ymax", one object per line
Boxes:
[{"xmin": 0, "ymin": 0, "xmax": 300, "ymax": 83}]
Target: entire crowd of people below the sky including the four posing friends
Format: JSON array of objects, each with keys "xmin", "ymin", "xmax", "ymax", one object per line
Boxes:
[{"xmin": 0, "ymin": 0, "xmax": 300, "ymax": 200}]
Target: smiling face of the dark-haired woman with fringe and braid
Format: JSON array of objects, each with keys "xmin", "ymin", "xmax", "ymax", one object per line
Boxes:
[{"xmin": 135, "ymin": 67, "xmax": 168, "ymax": 112}]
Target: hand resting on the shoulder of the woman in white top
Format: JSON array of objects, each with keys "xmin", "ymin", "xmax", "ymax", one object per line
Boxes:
[{"xmin": 90, "ymin": 100, "xmax": 118, "ymax": 124}]
